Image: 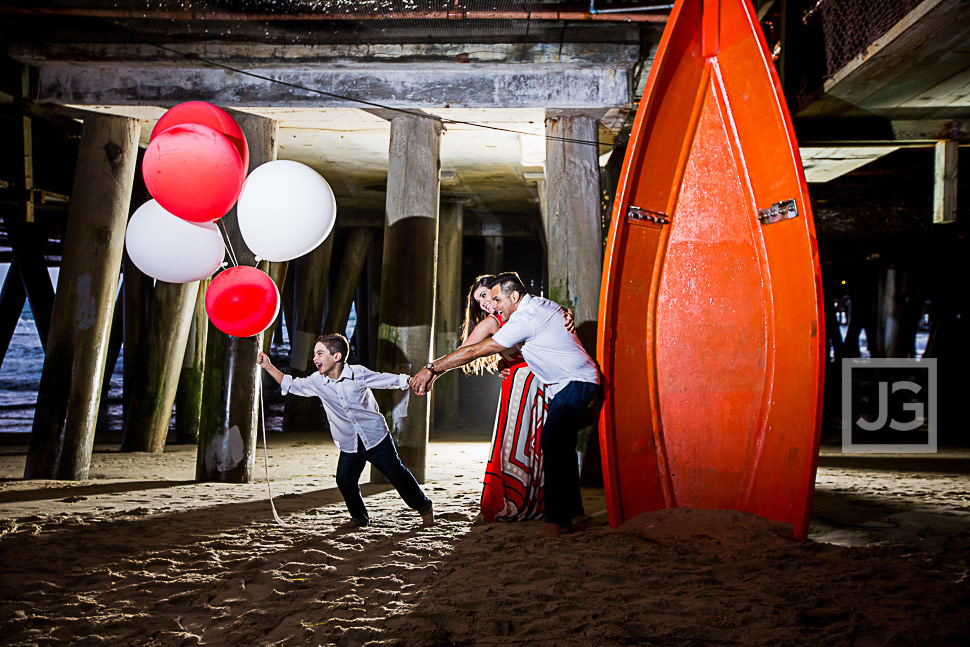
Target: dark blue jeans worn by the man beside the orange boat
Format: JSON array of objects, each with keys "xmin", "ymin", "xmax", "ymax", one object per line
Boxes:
[{"xmin": 542, "ymin": 382, "xmax": 601, "ymax": 526}]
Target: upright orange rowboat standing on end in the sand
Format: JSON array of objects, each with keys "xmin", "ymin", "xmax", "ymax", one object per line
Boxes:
[{"xmin": 598, "ymin": 0, "xmax": 825, "ymax": 539}]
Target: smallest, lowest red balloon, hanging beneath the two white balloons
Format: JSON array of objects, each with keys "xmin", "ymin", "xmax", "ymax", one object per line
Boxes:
[{"xmin": 205, "ymin": 265, "xmax": 280, "ymax": 337}]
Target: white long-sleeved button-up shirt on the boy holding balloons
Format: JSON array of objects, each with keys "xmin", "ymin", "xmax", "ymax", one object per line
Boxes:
[{"xmin": 280, "ymin": 364, "xmax": 409, "ymax": 454}]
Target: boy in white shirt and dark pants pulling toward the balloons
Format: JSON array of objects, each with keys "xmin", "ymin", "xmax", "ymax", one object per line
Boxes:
[{"xmin": 256, "ymin": 335, "xmax": 434, "ymax": 528}]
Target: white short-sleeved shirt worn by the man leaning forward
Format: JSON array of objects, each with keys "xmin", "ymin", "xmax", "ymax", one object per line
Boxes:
[{"xmin": 492, "ymin": 294, "xmax": 600, "ymax": 397}]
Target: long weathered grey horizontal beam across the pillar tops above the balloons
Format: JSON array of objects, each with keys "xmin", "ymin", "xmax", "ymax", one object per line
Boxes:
[{"xmin": 38, "ymin": 61, "xmax": 632, "ymax": 109}]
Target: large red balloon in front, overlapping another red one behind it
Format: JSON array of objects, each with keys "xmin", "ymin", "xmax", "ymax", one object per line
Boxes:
[{"xmin": 141, "ymin": 124, "xmax": 246, "ymax": 222}]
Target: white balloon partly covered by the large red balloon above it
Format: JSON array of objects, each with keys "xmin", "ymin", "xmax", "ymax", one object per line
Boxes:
[{"xmin": 125, "ymin": 200, "xmax": 226, "ymax": 283}]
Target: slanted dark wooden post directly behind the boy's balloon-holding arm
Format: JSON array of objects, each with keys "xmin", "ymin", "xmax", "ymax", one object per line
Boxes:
[{"xmin": 283, "ymin": 232, "xmax": 334, "ymax": 431}]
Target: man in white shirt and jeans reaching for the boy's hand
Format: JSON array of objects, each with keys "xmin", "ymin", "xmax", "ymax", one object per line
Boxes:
[{"xmin": 410, "ymin": 272, "xmax": 600, "ymax": 534}]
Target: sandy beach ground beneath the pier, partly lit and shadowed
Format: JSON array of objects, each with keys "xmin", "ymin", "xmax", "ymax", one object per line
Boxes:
[{"xmin": 0, "ymin": 434, "xmax": 970, "ymax": 646}]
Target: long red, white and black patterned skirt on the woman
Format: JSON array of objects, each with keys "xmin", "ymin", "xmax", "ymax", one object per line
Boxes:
[{"xmin": 482, "ymin": 362, "xmax": 549, "ymax": 521}]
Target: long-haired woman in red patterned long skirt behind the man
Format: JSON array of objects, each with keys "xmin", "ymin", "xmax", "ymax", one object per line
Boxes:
[{"xmin": 461, "ymin": 274, "xmax": 572, "ymax": 521}]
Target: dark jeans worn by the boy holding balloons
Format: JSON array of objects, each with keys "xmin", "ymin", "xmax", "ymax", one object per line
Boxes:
[{"xmin": 337, "ymin": 434, "xmax": 431, "ymax": 526}]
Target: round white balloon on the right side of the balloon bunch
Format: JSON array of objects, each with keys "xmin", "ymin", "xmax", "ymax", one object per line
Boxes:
[{"xmin": 236, "ymin": 160, "xmax": 337, "ymax": 261}]
